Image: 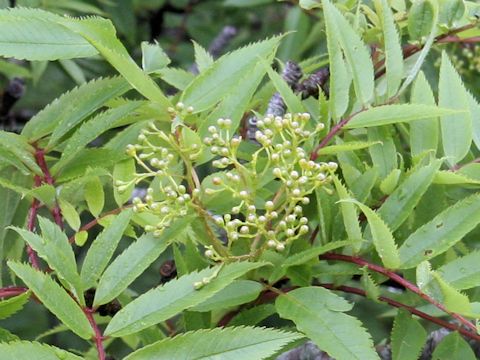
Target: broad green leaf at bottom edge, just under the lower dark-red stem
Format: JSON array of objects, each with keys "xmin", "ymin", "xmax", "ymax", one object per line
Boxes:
[{"xmin": 275, "ymin": 287, "xmax": 379, "ymax": 360}]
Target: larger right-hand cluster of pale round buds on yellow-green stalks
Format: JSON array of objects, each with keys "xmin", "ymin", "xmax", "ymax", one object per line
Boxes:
[{"xmin": 204, "ymin": 113, "xmax": 337, "ymax": 253}]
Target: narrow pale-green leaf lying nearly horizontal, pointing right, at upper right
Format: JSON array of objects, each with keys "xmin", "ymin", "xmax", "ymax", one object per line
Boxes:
[{"xmin": 345, "ymin": 104, "xmax": 466, "ymax": 129}]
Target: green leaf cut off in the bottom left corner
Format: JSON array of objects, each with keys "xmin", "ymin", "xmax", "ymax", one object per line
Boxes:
[{"xmin": 0, "ymin": 341, "xmax": 82, "ymax": 360}]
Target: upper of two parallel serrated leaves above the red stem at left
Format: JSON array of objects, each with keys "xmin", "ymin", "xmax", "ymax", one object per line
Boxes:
[{"xmin": 22, "ymin": 77, "xmax": 129, "ymax": 148}]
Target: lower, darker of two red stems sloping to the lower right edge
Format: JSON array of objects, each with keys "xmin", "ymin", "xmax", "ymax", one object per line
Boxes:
[{"xmin": 319, "ymin": 284, "xmax": 480, "ymax": 341}]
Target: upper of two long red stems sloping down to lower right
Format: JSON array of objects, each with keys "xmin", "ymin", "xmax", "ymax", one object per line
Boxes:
[{"xmin": 320, "ymin": 253, "xmax": 477, "ymax": 332}]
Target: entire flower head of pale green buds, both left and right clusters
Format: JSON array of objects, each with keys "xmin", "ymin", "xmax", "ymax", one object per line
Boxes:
[{"xmin": 116, "ymin": 105, "xmax": 337, "ymax": 261}]
